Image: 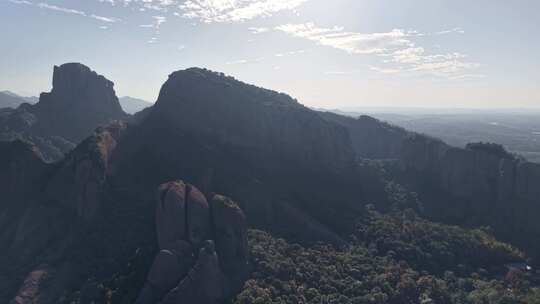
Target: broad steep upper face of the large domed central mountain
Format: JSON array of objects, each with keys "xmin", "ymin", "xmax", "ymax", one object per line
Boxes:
[{"xmin": 149, "ymin": 68, "xmax": 353, "ymax": 168}]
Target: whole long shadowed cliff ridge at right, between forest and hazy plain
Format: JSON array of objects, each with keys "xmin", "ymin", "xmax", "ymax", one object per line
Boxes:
[{"xmin": 322, "ymin": 113, "xmax": 540, "ymax": 256}]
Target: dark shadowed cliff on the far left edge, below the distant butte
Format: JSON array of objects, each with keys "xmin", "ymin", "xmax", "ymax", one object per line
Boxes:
[{"xmin": 0, "ymin": 141, "xmax": 74, "ymax": 303}]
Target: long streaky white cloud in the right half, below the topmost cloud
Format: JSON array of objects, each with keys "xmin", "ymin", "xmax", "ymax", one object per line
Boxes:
[{"xmin": 275, "ymin": 22, "xmax": 480, "ymax": 79}]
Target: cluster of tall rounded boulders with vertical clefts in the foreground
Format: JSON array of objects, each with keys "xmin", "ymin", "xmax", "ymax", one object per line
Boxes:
[{"xmin": 136, "ymin": 181, "xmax": 248, "ymax": 304}]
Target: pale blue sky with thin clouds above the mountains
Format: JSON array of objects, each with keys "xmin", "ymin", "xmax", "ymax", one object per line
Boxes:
[{"xmin": 0, "ymin": 0, "xmax": 540, "ymax": 108}]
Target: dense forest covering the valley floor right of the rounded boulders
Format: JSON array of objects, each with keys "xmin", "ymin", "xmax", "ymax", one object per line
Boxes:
[{"xmin": 234, "ymin": 211, "xmax": 540, "ymax": 304}]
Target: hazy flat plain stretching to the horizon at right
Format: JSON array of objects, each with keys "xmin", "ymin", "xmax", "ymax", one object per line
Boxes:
[{"xmin": 331, "ymin": 108, "xmax": 540, "ymax": 163}]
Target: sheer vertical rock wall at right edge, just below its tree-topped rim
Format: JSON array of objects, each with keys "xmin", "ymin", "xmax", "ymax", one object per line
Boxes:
[{"xmin": 401, "ymin": 135, "xmax": 540, "ymax": 203}]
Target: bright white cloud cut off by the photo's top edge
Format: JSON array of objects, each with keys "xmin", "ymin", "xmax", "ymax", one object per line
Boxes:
[{"xmin": 179, "ymin": 0, "xmax": 308, "ymax": 23}]
